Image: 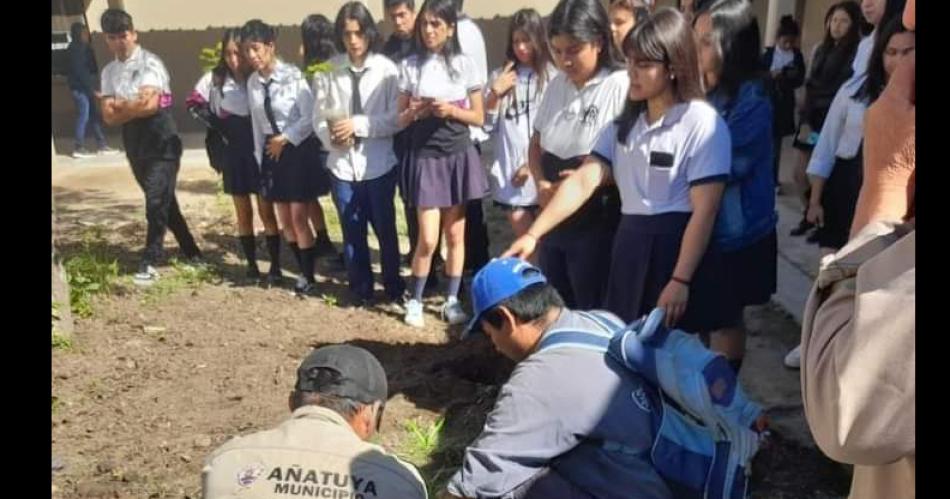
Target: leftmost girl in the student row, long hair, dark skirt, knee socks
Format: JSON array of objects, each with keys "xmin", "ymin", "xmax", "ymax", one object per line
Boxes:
[{"xmin": 187, "ymin": 28, "xmax": 281, "ymax": 284}]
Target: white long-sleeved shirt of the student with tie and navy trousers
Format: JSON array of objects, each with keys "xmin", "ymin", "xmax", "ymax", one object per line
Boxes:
[{"xmin": 313, "ymin": 54, "xmax": 400, "ymax": 182}]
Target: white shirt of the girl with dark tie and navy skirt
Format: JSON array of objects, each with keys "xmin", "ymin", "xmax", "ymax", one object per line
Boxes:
[{"xmin": 247, "ymin": 60, "xmax": 313, "ymax": 163}]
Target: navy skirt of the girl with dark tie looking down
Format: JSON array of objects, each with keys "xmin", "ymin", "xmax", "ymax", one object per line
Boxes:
[{"xmin": 261, "ymin": 136, "xmax": 330, "ymax": 203}]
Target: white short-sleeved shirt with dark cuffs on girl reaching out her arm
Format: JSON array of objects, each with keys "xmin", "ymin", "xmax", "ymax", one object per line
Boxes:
[{"xmin": 592, "ymin": 100, "xmax": 732, "ymax": 215}]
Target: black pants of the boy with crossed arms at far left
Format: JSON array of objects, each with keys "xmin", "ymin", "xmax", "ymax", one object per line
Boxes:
[{"xmin": 130, "ymin": 160, "xmax": 200, "ymax": 264}]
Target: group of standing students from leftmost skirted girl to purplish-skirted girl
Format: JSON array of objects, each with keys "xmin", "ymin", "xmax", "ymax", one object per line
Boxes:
[{"xmin": 180, "ymin": 0, "xmax": 498, "ymax": 327}]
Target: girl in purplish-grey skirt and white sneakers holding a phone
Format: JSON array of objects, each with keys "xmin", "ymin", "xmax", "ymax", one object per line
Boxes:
[{"xmin": 399, "ymin": 0, "xmax": 489, "ymax": 327}]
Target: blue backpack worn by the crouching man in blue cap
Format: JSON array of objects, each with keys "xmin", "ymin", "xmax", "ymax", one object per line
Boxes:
[{"xmin": 539, "ymin": 309, "xmax": 762, "ymax": 499}]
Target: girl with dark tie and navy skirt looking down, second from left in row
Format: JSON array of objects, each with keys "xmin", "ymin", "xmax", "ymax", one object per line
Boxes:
[{"xmin": 241, "ymin": 19, "xmax": 319, "ymax": 296}]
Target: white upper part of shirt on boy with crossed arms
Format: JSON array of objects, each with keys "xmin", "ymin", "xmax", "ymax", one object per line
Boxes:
[{"xmin": 101, "ymin": 46, "xmax": 172, "ymax": 108}]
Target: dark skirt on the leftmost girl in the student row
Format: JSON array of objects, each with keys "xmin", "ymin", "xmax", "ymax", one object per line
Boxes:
[{"xmin": 220, "ymin": 115, "xmax": 261, "ymax": 196}]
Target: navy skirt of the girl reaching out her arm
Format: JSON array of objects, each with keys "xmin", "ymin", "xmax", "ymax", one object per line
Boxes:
[{"xmin": 606, "ymin": 213, "xmax": 731, "ymax": 333}]
